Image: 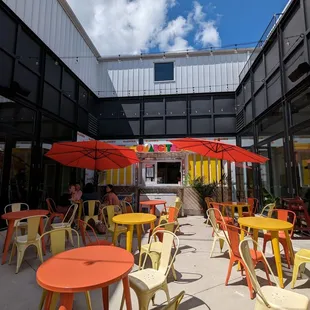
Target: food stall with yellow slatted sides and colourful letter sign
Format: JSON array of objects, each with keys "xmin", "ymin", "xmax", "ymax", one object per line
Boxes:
[{"xmin": 99, "ymin": 139, "xmax": 235, "ymax": 212}]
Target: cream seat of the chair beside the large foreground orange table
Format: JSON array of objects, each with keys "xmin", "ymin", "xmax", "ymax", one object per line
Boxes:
[{"xmin": 129, "ymin": 268, "xmax": 166, "ymax": 292}]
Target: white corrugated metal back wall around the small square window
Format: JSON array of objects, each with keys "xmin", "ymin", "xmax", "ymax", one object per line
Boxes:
[{"xmin": 98, "ymin": 52, "xmax": 249, "ymax": 97}]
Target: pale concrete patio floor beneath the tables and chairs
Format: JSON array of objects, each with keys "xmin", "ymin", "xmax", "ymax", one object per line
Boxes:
[{"xmin": 0, "ymin": 216, "xmax": 310, "ymax": 310}]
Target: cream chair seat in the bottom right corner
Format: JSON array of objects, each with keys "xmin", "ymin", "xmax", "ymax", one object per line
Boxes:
[{"xmin": 255, "ymin": 286, "xmax": 309, "ymax": 310}]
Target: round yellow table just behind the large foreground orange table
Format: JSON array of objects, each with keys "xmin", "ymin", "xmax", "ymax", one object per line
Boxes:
[{"xmin": 112, "ymin": 213, "xmax": 156, "ymax": 252}]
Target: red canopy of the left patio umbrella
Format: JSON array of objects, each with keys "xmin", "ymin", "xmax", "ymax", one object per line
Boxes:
[{"xmin": 45, "ymin": 140, "xmax": 139, "ymax": 170}]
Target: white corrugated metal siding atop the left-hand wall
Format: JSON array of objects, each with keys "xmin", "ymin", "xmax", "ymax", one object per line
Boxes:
[{"xmin": 3, "ymin": 0, "xmax": 98, "ymax": 91}]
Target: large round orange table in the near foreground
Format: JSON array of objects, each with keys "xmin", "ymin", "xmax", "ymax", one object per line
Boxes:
[{"xmin": 37, "ymin": 245, "xmax": 134, "ymax": 310}]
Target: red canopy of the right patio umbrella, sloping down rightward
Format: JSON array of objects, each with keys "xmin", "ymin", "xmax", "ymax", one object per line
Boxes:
[{"xmin": 171, "ymin": 138, "xmax": 268, "ymax": 164}]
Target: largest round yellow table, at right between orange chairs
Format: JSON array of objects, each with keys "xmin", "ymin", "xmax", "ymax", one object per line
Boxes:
[{"xmin": 238, "ymin": 217, "xmax": 294, "ymax": 288}]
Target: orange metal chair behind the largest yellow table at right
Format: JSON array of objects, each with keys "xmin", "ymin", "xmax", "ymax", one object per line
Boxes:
[{"xmin": 263, "ymin": 209, "xmax": 296, "ymax": 268}]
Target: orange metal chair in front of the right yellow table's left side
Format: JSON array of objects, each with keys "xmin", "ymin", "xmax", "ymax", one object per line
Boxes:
[{"xmin": 225, "ymin": 225, "xmax": 272, "ymax": 299}]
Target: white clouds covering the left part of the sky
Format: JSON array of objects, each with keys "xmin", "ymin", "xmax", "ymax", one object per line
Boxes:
[{"xmin": 67, "ymin": 0, "xmax": 220, "ymax": 55}]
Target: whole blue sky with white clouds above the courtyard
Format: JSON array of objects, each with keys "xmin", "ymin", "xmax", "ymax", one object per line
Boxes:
[{"xmin": 67, "ymin": 0, "xmax": 288, "ymax": 56}]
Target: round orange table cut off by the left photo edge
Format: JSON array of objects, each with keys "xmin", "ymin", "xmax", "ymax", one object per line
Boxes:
[{"xmin": 1, "ymin": 210, "xmax": 49, "ymax": 265}]
